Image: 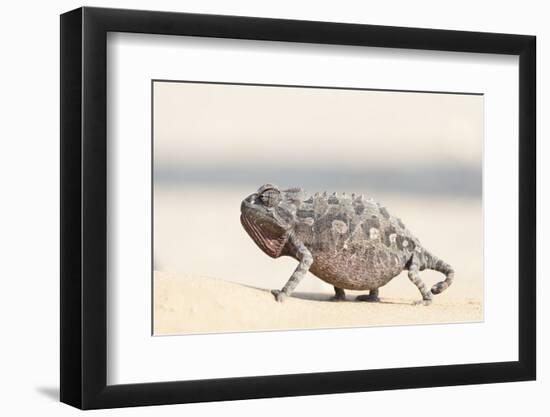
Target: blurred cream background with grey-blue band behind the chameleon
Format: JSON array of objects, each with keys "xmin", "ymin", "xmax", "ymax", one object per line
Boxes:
[{"xmin": 153, "ymin": 82, "xmax": 483, "ymax": 301}]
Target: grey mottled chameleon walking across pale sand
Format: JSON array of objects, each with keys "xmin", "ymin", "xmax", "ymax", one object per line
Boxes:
[{"xmin": 240, "ymin": 184, "xmax": 454, "ymax": 305}]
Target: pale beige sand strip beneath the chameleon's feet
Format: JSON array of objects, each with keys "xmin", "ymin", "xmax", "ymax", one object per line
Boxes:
[{"xmin": 154, "ymin": 271, "xmax": 483, "ymax": 335}]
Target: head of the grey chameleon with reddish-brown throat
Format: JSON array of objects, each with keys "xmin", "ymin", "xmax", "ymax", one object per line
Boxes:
[{"xmin": 241, "ymin": 184, "xmax": 297, "ymax": 258}]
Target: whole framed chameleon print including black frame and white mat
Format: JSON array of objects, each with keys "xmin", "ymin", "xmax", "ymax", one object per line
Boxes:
[{"xmin": 60, "ymin": 7, "xmax": 536, "ymax": 409}]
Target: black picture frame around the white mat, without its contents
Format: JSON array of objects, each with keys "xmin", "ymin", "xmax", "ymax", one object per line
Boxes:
[{"xmin": 60, "ymin": 7, "xmax": 536, "ymax": 409}]
